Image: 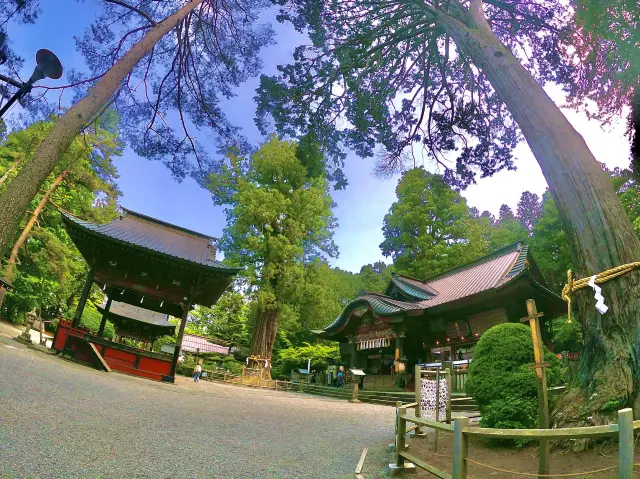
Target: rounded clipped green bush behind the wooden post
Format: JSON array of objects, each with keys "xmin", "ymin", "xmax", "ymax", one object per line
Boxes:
[{"xmin": 466, "ymin": 323, "xmax": 562, "ymax": 438}]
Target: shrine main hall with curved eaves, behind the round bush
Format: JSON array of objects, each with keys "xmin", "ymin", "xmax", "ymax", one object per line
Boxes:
[{"xmin": 314, "ymin": 243, "xmax": 566, "ymax": 376}]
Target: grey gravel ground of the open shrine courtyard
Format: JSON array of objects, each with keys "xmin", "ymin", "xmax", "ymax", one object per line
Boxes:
[{"xmin": 0, "ymin": 335, "xmax": 394, "ymax": 479}]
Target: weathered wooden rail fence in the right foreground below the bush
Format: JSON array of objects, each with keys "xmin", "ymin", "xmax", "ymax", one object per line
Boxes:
[{"xmin": 389, "ymin": 403, "xmax": 640, "ymax": 479}]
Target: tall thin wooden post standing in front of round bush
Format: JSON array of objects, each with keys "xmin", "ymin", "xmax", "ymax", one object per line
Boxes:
[{"xmin": 521, "ymin": 299, "xmax": 549, "ymax": 478}]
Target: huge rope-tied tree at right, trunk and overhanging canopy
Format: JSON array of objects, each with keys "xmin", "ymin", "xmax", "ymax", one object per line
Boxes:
[{"xmin": 258, "ymin": 0, "xmax": 640, "ymax": 423}]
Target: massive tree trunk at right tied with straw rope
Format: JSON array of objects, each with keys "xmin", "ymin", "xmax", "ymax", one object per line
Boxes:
[{"xmin": 438, "ymin": 1, "xmax": 640, "ymax": 422}]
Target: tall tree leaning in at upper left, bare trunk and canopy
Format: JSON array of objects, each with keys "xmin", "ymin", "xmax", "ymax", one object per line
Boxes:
[{"xmin": 0, "ymin": 0, "xmax": 272, "ymax": 258}]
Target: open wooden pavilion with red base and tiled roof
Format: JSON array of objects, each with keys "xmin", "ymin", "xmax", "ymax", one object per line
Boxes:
[{"xmin": 52, "ymin": 209, "xmax": 239, "ymax": 382}]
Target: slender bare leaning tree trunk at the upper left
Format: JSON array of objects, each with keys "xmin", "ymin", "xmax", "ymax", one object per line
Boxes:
[{"xmin": 0, "ymin": 0, "xmax": 204, "ymax": 253}]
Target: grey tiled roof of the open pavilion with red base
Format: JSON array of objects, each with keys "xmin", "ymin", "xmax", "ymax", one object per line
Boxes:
[{"xmin": 62, "ymin": 209, "xmax": 237, "ymax": 271}]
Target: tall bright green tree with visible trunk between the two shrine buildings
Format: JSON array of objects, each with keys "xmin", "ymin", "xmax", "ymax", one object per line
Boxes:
[{"xmin": 210, "ymin": 138, "xmax": 337, "ymax": 372}]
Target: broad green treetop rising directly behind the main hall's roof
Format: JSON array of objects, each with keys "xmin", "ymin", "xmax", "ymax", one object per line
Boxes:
[{"xmin": 380, "ymin": 168, "xmax": 487, "ymax": 279}]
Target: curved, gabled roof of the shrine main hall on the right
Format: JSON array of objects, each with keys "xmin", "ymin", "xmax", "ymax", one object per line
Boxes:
[{"xmin": 314, "ymin": 243, "xmax": 562, "ymax": 337}]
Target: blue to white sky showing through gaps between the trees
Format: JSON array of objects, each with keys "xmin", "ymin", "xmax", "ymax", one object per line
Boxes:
[{"xmin": 0, "ymin": 0, "xmax": 629, "ymax": 272}]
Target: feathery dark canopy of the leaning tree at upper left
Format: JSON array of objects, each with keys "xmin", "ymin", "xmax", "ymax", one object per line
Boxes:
[{"xmin": 5, "ymin": 0, "xmax": 274, "ymax": 181}]
